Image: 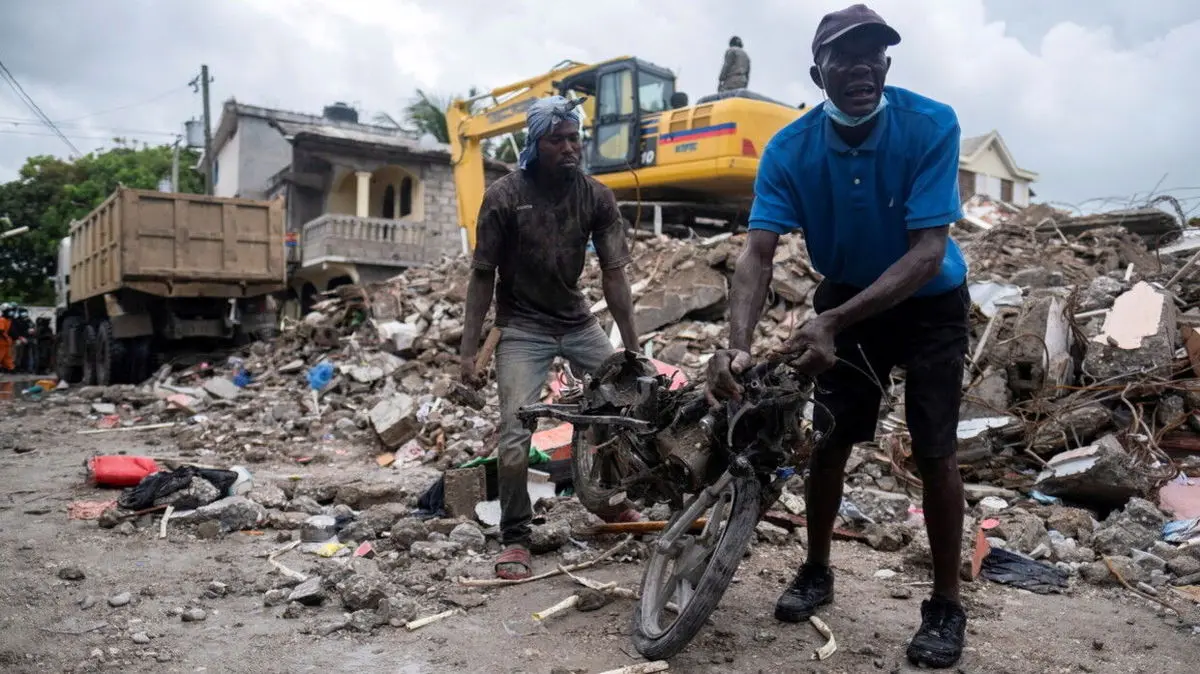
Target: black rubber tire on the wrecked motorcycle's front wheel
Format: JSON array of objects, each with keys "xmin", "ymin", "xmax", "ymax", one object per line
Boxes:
[{"xmin": 632, "ymin": 476, "xmax": 762, "ymax": 660}]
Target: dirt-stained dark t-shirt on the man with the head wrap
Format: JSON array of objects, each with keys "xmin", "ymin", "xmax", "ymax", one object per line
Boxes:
[{"xmin": 472, "ymin": 170, "xmax": 632, "ymax": 336}]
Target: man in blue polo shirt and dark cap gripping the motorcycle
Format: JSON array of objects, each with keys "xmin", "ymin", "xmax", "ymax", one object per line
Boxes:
[{"xmin": 708, "ymin": 5, "xmax": 970, "ymax": 667}]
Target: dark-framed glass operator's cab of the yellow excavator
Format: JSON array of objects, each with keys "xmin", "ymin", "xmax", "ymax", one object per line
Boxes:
[{"xmin": 558, "ymin": 59, "xmax": 686, "ymax": 175}]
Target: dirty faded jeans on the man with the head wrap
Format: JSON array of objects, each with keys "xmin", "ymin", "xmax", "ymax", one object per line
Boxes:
[{"xmin": 496, "ymin": 321, "xmax": 613, "ymax": 546}]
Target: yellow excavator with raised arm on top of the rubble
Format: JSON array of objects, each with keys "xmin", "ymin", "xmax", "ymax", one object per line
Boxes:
[{"xmin": 446, "ymin": 56, "xmax": 806, "ymax": 249}]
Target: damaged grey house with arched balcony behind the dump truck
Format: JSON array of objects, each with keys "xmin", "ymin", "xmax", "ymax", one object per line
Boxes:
[{"xmin": 202, "ymin": 100, "xmax": 510, "ymax": 314}]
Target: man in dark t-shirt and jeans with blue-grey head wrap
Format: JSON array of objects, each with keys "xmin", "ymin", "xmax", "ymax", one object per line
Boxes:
[{"xmin": 461, "ymin": 96, "xmax": 637, "ymax": 578}]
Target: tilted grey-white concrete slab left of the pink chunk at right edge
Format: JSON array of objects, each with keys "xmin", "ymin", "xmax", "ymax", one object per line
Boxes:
[{"xmin": 1036, "ymin": 435, "xmax": 1154, "ymax": 507}]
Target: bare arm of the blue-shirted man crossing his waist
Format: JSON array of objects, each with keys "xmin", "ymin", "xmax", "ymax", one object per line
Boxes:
[{"xmin": 826, "ymin": 225, "xmax": 950, "ymax": 332}]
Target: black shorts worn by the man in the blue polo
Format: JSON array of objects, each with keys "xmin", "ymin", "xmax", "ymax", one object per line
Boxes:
[{"xmin": 812, "ymin": 281, "xmax": 971, "ymax": 458}]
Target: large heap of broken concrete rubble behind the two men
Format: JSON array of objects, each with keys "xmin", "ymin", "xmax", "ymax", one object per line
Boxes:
[{"xmin": 30, "ymin": 195, "xmax": 1200, "ymax": 630}]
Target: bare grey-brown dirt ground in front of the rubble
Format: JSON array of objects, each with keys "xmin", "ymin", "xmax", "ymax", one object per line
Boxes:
[{"xmin": 0, "ymin": 378, "xmax": 1200, "ymax": 674}]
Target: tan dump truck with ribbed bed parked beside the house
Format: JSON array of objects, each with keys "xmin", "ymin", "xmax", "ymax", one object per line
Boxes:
[{"xmin": 55, "ymin": 187, "xmax": 287, "ymax": 386}]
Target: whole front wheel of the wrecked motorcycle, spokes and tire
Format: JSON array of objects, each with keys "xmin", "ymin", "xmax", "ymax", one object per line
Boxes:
[{"xmin": 632, "ymin": 473, "xmax": 762, "ymax": 660}]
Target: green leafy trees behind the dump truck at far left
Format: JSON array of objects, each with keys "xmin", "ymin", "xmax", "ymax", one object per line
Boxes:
[{"xmin": 0, "ymin": 138, "xmax": 204, "ymax": 305}]
